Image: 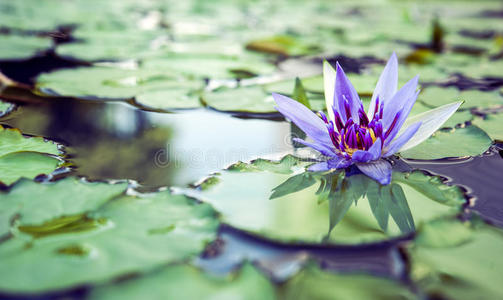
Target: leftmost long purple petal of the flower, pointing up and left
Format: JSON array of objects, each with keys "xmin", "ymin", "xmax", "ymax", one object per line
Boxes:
[{"xmin": 272, "ymin": 93, "xmax": 332, "ymax": 145}]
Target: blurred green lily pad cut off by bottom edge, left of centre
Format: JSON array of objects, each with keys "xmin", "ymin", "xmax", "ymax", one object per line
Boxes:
[{"xmin": 89, "ymin": 264, "xmax": 276, "ymax": 300}]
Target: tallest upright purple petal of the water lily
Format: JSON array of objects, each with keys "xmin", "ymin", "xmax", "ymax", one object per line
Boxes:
[{"xmin": 368, "ymin": 52, "xmax": 398, "ymax": 119}]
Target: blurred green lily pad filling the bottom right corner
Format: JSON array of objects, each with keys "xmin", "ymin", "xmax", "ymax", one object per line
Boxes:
[{"xmin": 408, "ymin": 220, "xmax": 503, "ymax": 300}]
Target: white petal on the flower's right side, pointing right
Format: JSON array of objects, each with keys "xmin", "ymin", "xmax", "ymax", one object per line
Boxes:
[{"xmin": 398, "ymin": 101, "xmax": 463, "ymax": 151}]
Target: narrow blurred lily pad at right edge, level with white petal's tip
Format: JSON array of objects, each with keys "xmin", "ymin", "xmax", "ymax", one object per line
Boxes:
[{"xmin": 419, "ymin": 87, "xmax": 503, "ymax": 109}]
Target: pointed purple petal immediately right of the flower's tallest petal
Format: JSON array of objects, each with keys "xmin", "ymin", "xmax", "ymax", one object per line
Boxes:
[{"xmin": 379, "ymin": 76, "xmax": 419, "ymax": 130}]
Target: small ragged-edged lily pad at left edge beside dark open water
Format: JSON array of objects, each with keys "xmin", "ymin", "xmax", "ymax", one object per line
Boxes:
[{"xmin": 0, "ymin": 126, "xmax": 62, "ymax": 185}]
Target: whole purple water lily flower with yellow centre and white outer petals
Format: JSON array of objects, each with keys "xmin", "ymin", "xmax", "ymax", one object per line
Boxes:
[{"xmin": 273, "ymin": 53, "xmax": 462, "ymax": 185}]
